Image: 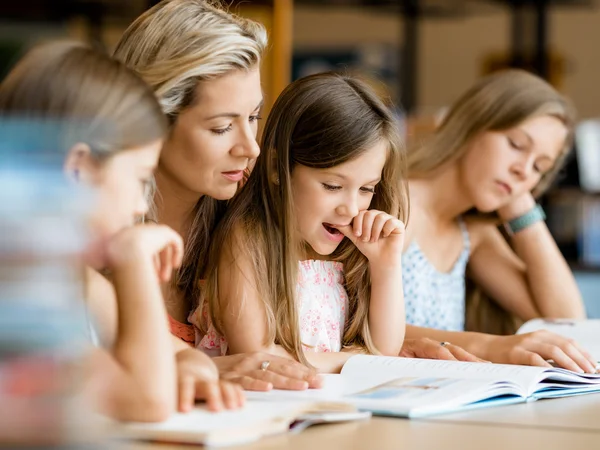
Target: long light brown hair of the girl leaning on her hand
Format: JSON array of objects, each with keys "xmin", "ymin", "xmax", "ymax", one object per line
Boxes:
[{"xmin": 408, "ymin": 70, "xmax": 575, "ymax": 334}]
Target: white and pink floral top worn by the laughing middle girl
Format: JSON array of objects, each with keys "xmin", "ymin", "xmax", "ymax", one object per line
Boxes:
[{"xmin": 195, "ymin": 260, "xmax": 348, "ymax": 356}]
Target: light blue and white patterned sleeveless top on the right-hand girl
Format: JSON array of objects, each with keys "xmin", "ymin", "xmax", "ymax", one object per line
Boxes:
[{"xmin": 402, "ymin": 219, "xmax": 471, "ymax": 331}]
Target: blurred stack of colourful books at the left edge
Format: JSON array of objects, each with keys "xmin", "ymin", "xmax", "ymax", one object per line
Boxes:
[{"xmin": 0, "ymin": 151, "xmax": 105, "ymax": 446}]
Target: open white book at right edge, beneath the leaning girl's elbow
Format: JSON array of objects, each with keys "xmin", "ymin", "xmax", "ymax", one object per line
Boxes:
[{"xmin": 517, "ymin": 319, "xmax": 600, "ymax": 362}]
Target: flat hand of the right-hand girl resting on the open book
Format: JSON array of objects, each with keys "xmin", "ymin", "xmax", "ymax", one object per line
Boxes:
[{"xmin": 484, "ymin": 330, "xmax": 596, "ymax": 373}]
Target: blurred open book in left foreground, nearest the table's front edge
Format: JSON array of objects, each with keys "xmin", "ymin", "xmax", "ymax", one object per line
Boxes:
[{"xmin": 116, "ymin": 400, "xmax": 371, "ymax": 447}]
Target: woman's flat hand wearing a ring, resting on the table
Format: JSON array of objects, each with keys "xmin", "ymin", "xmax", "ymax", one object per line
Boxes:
[{"xmin": 213, "ymin": 352, "xmax": 323, "ymax": 391}]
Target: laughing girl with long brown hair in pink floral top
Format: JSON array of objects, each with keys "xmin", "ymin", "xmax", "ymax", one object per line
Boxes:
[{"xmin": 198, "ymin": 73, "xmax": 408, "ymax": 372}]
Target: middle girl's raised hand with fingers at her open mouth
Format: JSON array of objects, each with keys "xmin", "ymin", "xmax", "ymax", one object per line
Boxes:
[{"xmin": 336, "ymin": 209, "xmax": 405, "ymax": 268}]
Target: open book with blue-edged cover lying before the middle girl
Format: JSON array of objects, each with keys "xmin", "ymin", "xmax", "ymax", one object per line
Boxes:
[{"xmin": 248, "ymin": 355, "xmax": 600, "ymax": 417}]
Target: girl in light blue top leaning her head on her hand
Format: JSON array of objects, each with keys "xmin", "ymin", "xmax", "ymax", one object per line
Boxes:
[{"xmin": 403, "ymin": 70, "xmax": 594, "ymax": 372}]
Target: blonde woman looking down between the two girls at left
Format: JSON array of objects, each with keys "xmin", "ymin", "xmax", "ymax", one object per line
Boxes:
[{"xmin": 115, "ymin": 0, "xmax": 328, "ymax": 409}]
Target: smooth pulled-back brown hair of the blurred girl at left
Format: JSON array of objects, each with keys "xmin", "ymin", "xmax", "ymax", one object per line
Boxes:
[{"xmin": 0, "ymin": 41, "xmax": 167, "ymax": 160}]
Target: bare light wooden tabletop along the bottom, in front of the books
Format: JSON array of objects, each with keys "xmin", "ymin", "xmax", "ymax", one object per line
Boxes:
[{"xmin": 127, "ymin": 395, "xmax": 600, "ymax": 450}]
